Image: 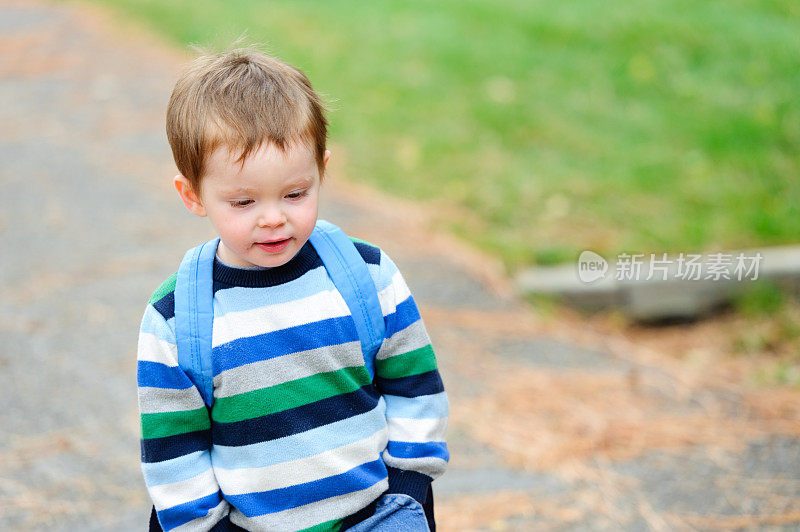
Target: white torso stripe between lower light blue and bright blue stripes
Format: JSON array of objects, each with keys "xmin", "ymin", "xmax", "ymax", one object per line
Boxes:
[{"xmin": 214, "ymin": 428, "xmax": 387, "ymax": 495}]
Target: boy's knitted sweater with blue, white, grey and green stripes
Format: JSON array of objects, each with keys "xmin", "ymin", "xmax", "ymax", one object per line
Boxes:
[{"xmin": 138, "ymin": 242, "xmax": 449, "ymax": 531}]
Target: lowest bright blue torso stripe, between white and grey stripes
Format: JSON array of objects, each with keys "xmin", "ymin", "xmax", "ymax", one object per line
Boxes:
[{"xmin": 226, "ymin": 458, "xmax": 387, "ymax": 517}]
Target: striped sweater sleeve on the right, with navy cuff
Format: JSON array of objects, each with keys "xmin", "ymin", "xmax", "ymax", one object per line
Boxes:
[{"xmin": 375, "ymin": 251, "xmax": 449, "ymax": 504}]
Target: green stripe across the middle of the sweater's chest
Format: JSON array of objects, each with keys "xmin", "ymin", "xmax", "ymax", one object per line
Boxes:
[{"xmin": 211, "ymin": 366, "xmax": 370, "ymax": 423}]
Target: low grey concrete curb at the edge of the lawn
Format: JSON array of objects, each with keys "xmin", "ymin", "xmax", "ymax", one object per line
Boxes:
[{"xmin": 515, "ymin": 246, "xmax": 800, "ymax": 321}]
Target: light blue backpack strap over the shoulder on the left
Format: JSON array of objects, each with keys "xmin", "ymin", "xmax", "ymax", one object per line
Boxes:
[{"xmin": 175, "ymin": 238, "xmax": 219, "ymax": 406}]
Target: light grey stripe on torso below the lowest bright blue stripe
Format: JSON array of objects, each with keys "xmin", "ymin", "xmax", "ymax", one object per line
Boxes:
[{"xmin": 231, "ymin": 479, "xmax": 389, "ymax": 532}]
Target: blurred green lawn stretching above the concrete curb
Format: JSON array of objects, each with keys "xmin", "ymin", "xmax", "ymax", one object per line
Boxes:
[{"xmin": 79, "ymin": 0, "xmax": 800, "ymax": 268}]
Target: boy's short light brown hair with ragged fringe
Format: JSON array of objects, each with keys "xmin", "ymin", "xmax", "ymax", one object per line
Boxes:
[{"xmin": 167, "ymin": 48, "xmax": 328, "ymax": 194}]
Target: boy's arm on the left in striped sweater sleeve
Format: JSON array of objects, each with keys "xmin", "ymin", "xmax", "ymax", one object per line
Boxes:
[{"xmin": 137, "ymin": 294, "xmax": 229, "ymax": 530}]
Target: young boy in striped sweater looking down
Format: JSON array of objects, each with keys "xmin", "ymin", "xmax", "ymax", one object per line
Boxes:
[{"xmin": 138, "ymin": 49, "xmax": 448, "ymax": 531}]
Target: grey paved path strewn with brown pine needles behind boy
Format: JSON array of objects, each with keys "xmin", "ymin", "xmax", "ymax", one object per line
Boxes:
[{"xmin": 0, "ymin": 1, "xmax": 800, "ymax": 531}]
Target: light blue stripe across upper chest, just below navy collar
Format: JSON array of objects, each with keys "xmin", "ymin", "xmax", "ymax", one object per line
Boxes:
[{"xmin": 214, "ymin": 265, "xmax": 333, "ymax": 312}]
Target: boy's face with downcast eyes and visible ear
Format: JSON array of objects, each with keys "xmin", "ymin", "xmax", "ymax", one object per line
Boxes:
[{"xmin": 175, "ymin": 143, "xmax": 330, "ymax": 267}]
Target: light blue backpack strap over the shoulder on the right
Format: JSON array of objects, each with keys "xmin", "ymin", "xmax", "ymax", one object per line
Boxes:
[{"xmin": 309, "ymin": 220, "xmax": 386, "ymax": 378}]
